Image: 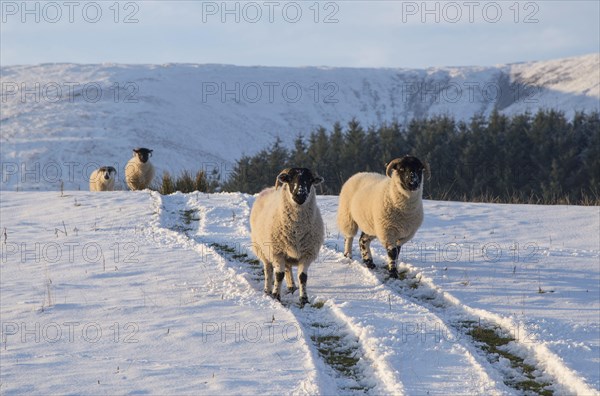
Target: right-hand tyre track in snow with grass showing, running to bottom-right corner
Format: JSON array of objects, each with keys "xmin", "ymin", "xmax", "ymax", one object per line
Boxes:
[{"xmin": 330, "ymin": 241, "xmax": 598, "ymax": 395}]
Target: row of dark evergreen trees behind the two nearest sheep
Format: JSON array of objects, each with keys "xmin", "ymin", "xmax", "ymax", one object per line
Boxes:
[{"xmin": 222, "ymin": 110, "xmax": 600, "ymax": 204}]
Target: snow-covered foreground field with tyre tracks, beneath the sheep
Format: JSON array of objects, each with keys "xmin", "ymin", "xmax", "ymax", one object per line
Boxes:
[{"xmin": 0, "ymin": 191, "xmax": 600, "ymax": 395}]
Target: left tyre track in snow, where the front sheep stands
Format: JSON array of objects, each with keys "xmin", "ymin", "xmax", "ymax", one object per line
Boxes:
[{"xmin": 186, "ymin": 194, "xmax": 404, "ymax": 395}]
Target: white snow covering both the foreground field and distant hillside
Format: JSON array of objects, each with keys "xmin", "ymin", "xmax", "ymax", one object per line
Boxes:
[{"xmin": 0, "ymin": 54, "xmax": 600, "ymax": 395}]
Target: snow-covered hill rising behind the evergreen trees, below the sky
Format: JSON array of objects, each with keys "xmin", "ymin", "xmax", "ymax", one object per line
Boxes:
[{"xmin": 0, "ymin": 54, "xmax": 600, "ymax": 190}]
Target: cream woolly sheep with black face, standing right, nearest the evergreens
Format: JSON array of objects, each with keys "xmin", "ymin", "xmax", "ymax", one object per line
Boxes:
[{"xmin": 337, "ymin": 156, "xmax": 429, "ymax": 278}]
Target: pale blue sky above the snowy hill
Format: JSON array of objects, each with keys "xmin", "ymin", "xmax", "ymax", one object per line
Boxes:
[{"xmin": 0, "ymin": 0, "xmax": 600, "ymax": 68}]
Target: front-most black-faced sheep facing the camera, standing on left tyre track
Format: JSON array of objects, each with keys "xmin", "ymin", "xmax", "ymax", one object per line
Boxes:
[{"xmin": 250, "ymin": 168, "xmax": 324, "ymax": 306}]
